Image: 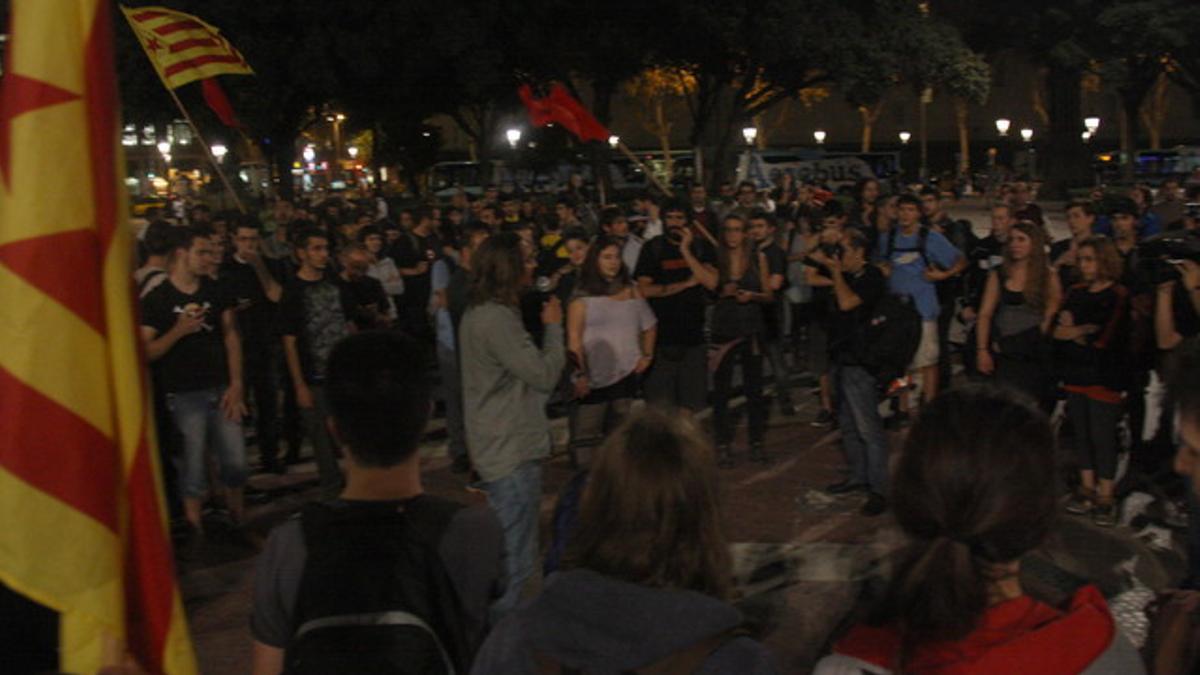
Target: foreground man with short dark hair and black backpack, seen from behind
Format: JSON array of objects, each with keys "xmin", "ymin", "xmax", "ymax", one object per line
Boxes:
[{"xmin": 250, "ymin": 331, "xmax": 504, "ymax": 675}]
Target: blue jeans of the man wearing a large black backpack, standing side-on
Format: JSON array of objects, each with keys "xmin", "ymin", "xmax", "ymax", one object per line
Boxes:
[{"xmin": 833, "ymin": 365, "xmax": 888, "ymax": 495}]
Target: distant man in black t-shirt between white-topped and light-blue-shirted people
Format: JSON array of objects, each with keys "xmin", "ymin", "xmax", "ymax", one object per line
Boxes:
[{"xmin": 391, "ymin": 207, "xmax": 442, "ymax": 341}]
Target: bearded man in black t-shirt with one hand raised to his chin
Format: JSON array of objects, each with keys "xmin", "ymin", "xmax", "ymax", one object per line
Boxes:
[{"xmin": 634, "ymin": 204, "xmax": 718, "ymax": 412}]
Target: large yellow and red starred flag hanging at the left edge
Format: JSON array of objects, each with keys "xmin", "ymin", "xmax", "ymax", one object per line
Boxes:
[{"xmin": 0, "ymin": 0, "xmax": 196, "ymax": 674}]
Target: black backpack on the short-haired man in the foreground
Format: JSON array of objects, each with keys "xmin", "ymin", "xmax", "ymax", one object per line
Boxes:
[{"xmin": 284, "ymin": 496, "xmax": 472, "ymax": 675}]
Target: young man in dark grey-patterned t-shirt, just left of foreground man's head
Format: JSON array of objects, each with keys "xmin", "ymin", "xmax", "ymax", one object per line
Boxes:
[{"xmin": 280, "ymin": 229, "xmax": 350, "ymax": 497}]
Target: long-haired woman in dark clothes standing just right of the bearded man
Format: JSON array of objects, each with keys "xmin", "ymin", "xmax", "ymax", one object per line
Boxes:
[{"xmin": 710, "ymin": 215, "xmax": 774, "ymax": 467}]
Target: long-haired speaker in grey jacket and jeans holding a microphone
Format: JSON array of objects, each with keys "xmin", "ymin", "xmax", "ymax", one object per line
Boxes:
[{"xmin": 458, "ymin": 233, "xmax": 565, "ymax": 620}]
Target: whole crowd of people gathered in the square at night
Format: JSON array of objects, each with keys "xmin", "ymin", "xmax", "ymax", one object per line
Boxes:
[{"xmin": 134, "ymin": 171, "xmax": 1200, "ymax": 673}]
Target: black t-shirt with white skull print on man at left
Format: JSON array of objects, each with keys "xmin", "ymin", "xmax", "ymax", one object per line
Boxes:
[{"xmin": 142, "ymin": 277, "xmax": 232, "ymax": 394}]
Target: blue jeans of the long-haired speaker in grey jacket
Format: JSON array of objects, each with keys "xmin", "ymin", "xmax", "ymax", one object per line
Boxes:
[{"xmin": 482, "ymin": 460, "xmax": 541, "ymax": 626}]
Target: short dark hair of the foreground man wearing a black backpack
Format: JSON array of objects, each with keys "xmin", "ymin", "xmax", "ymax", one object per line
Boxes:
[{"xmin": 325, "ymin": 330, "xmax": 433, "ymax": 468}]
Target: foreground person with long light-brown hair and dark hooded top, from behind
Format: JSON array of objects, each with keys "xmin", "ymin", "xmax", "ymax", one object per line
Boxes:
[{"xmin": 473, "ymin": 407, "xmax": 775, "ymax": 675}]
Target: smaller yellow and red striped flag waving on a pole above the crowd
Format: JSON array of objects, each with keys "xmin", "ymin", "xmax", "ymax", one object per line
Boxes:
[{"xmin": 121, "ymin": 6, "xmax": 254, "ymax": 89}]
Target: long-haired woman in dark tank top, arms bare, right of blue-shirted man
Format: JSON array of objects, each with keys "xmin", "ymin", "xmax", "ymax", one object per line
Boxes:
[{"xmin": 976, "ymin": 221, "xmax": 1062, "ymax": 402}]
